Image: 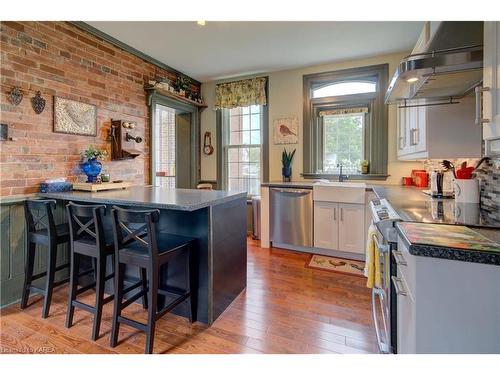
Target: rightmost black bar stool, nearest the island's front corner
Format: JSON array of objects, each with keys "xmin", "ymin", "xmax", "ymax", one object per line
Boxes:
[{"xmin": 110, "ymin": 206, "xmax": 195, "ymax": 354}]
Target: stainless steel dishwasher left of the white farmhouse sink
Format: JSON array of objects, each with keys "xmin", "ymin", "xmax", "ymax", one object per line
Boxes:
[{"xmin": 270, "ymin": 188, "xmax": 313, "ymax": 247}]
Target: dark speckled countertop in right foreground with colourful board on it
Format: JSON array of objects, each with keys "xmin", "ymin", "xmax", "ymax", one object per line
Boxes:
[{"xmin": 396, "ymin": 222, "xmax": 500, "ymax": 265}]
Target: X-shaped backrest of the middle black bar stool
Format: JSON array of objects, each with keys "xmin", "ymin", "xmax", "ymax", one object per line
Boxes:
[{"xmin": 66, "ymin": 202, "xmax": 106, "ymax": 248}]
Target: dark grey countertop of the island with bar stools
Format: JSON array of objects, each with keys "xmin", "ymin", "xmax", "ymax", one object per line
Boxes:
[{"xmin": 38, "ymin": 186, "xmax": 247, "ymax": 211}]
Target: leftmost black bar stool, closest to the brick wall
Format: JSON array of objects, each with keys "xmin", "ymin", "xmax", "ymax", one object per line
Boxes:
[{"xmin": 21, "ymin": 200, "xmax": 69, "ymax": 319}]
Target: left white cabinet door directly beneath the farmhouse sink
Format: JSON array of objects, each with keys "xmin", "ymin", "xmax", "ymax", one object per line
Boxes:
[{"xmin": 314, "ymin": 202, "xmax": 339, "ymax": 250}]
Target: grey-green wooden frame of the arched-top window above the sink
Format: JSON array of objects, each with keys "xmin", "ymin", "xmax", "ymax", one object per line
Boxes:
[{"xmin": 302, "ymin": 64, "xmax": 389, "ymax": 180}]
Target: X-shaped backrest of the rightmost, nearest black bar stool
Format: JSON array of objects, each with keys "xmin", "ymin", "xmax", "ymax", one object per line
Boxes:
[{"xmin": 111, "ymin": 206, "xmax": 160, "ymax": 258}]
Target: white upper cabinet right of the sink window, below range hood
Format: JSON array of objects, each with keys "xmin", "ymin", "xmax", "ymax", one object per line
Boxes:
[{"xmin": 397, "ymin": 96, "xmax": 482, "ymax": 160}]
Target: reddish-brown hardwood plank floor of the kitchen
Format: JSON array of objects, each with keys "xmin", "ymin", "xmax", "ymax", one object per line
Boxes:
[{"xmin": 0, "ymin": 239, "xmax": 377, "ymax": 354}]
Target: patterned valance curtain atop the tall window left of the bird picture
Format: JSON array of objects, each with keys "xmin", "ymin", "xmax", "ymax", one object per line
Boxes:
[{"xmin": 215, "ymin": 77, "xmax": 267, "ymax": 109}]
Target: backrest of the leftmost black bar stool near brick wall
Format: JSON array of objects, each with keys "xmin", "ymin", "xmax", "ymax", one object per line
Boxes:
[{"xmin": 24, "ymin": 199, "xmax": 57, "ymax": 239}]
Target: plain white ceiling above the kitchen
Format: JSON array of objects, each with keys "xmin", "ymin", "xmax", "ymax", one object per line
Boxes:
[{"xmin": 87, "ymin": 21, "xmax": 423, "ymax": 82}]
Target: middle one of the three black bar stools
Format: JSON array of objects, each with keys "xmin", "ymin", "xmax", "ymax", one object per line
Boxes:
[{"xmin": 66, "ymin": 202, "xmax": 114, "ymax": 341}]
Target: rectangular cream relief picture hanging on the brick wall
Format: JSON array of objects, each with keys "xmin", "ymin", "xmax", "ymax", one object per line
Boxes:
[{"xmin": 54, "ymin": 97, "xmax": 97, "ymax": 137}]
